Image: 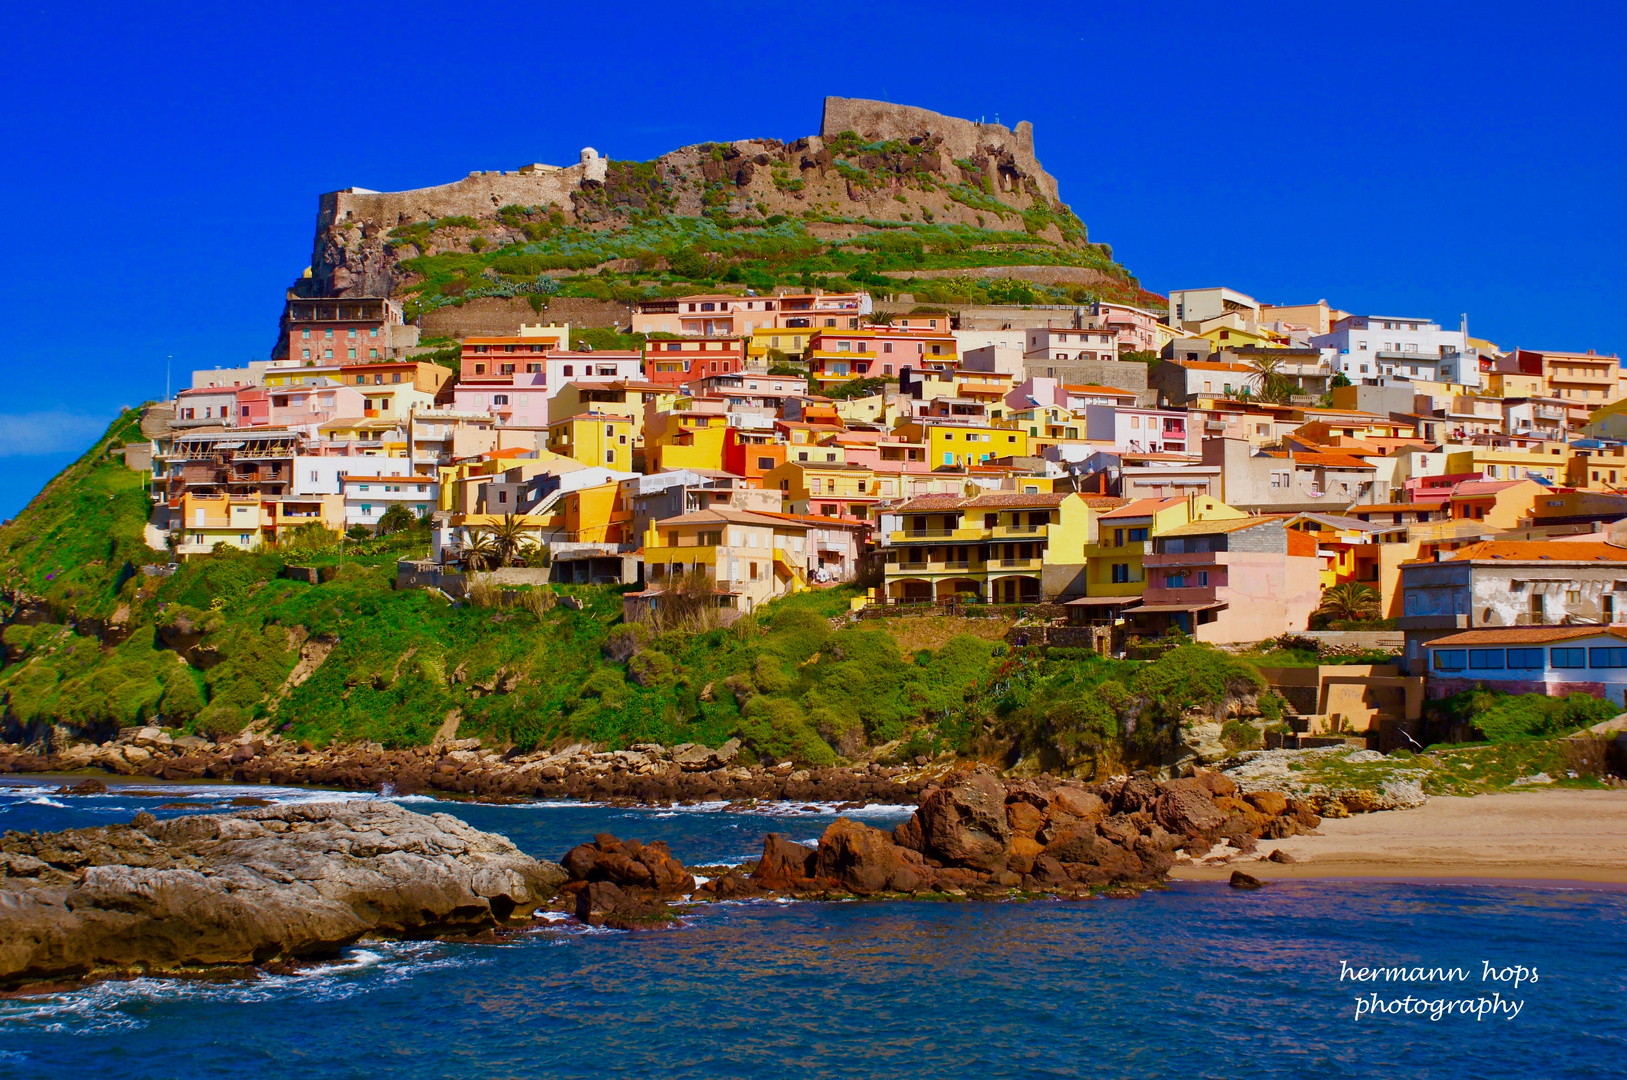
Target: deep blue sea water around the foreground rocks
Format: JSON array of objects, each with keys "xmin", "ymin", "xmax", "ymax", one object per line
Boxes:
[{"xmin": 0, "ymin": 782, "xmax": 1627, "ymax": 1080}]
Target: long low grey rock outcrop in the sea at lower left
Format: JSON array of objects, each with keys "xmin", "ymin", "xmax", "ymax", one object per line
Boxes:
[{"xmin": 0, "ymin": 802, "xmax": 565, "ymax": 984}]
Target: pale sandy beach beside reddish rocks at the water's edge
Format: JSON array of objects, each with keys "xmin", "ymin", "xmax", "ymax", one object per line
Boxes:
[{"xmin": 1170, "ymin": 790, "xmax": 1627, "ymax": 885}]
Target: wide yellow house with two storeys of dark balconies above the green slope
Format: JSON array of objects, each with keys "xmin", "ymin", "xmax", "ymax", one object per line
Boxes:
[{"xmin": 883, "ymin": 491, "xmax": 1092, "ymax": 603}]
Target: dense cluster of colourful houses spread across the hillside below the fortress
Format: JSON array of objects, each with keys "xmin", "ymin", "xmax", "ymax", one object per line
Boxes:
[{"xmin": 143, "ymin": 278, "xmax": 1627, "ymax": 699}]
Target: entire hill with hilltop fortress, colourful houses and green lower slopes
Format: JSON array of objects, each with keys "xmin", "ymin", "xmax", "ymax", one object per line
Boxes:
[{"xmin": 12, "ymin": 98, "xmax": 1627, "ymax": 783}]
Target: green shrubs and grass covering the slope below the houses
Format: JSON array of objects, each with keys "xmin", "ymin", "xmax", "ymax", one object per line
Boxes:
[{"xmin": 9, "ymin": 412, "xmax": 1614, "ymax": 784}]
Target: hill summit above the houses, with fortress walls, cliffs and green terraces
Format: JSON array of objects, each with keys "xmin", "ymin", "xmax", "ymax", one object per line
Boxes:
[{"xmin": 296, "ymin": 98, "xmax": 1162, "ymax": 333}]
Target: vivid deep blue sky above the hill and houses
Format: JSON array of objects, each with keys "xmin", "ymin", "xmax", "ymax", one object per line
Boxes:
[{"xmin": 0, "ymin": 0, "xmax": 1627, "ymax": 516}]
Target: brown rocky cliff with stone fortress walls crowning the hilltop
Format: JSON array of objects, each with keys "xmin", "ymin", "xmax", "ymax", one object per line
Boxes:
[{"xmin": 298, "ymin": 98, "xmax": 1110, "ymax": 296}]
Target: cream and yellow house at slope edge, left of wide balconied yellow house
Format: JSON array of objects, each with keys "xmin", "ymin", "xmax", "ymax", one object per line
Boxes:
[{"xmin": 644, "ymin": 506, "xmax": 809, "ymax": 612}]
